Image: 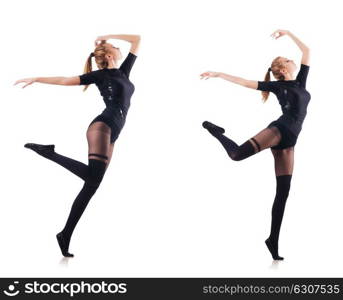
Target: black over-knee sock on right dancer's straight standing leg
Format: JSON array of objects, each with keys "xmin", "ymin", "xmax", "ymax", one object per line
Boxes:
[{"xmin": 266, "ymin": 175, "xmax": 292, "ymax": 259}]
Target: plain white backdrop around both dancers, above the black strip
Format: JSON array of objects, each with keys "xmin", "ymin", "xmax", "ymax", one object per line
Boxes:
[{"xmin": 0, "ymin": 0, "xmax": 343, "ymax": 277}]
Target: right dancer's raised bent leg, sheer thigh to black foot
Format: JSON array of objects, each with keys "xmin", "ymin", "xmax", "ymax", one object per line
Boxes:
[{"xmin": 203, "ymin": 121, "xmax": 281, "ymax": 161}]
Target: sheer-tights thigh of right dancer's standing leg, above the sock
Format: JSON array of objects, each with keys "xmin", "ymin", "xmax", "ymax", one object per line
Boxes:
[{"xmin": 270, "ymin": 147, "xmax": 294, "ymax": 176}]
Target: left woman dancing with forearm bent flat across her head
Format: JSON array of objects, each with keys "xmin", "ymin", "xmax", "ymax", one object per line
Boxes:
[{"xmin": 15, "ymin": 34, "xmax": 140, "ymax": 257}]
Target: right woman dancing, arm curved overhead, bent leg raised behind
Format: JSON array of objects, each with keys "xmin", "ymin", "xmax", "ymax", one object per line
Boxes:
[{"xmin": 200, "ymin": 30, "xmax": 311, "ymax": 260}]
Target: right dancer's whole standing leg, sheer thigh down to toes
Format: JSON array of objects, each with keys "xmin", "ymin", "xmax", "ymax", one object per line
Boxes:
[{"xmin": 265, "ymin": 147, "xmax": 294, "ymax": 260}]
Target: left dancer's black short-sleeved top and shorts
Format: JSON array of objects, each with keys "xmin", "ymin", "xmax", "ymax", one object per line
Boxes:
[{"xmin": 79, "ymin": 52, "xmax": 137, "ymax": 144}]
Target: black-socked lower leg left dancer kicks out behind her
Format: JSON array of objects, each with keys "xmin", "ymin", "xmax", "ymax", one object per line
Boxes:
[{"xmin": 25, "ymin": 143, "xmax": 88, "ymax": 180}]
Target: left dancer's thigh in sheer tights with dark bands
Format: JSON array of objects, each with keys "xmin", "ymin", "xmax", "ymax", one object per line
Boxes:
[{"xmin": 87, "ymin": 121, "xmax": 111, "ymax": 162}]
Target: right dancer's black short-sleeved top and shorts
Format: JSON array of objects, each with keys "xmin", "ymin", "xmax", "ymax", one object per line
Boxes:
[{"xmin": 257, "ymin": 64, "xmax": 311, "ymax": 149}]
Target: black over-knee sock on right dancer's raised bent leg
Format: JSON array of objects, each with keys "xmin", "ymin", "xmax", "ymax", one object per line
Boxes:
[{"xmin": 205, "ymin": 122, "xmax": 257, "ymax": 161}]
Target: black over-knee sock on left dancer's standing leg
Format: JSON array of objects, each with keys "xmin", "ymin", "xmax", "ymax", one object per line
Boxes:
[{"xmin": 57, "ymin": 159, "xmax": 106, "ymax": 256}]
